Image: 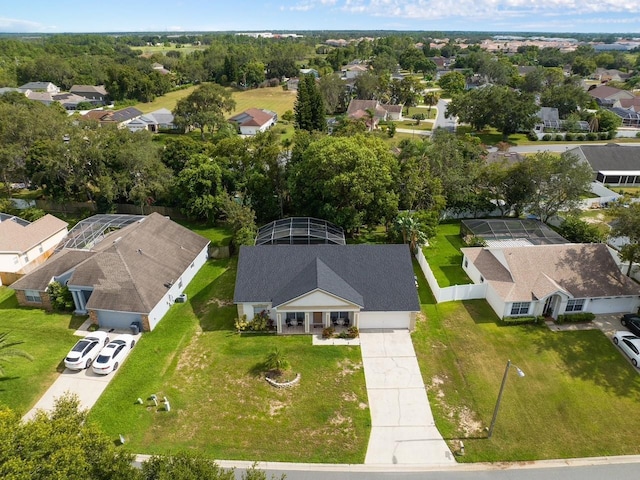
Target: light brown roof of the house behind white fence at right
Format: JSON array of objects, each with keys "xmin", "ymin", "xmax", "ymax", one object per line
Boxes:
[{"xmin": 462, "ymin": 243, "xmax": 640, "ymax": 302}]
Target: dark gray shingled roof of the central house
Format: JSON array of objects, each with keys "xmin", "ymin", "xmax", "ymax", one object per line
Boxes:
[{"xmin": 233, "ymin": 245, "xmax": 420, "ymax": 312}]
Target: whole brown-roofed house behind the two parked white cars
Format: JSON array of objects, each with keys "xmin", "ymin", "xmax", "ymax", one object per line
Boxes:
[{"xmin": 12, "ymin": 213, "xmax": 209, "ymax": 331}]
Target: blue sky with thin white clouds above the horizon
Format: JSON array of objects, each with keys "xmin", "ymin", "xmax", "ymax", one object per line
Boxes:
[{"xmin": 0, "ymin": 0, "xmax": 640, "ymax": 36}]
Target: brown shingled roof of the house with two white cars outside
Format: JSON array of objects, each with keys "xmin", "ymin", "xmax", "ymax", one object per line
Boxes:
[{"xmin": 68, "ymin": 213, "xmax": 209, "ymax": 313}]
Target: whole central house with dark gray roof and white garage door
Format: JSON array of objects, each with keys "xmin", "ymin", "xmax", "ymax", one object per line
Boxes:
[{"xmin": 233, "ymin": 244, "xmax": 420, "ymax": 333}]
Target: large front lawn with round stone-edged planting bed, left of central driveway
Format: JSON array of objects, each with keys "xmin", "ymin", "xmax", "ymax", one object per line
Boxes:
[{"xmin": 90, "ymin": 259, "xmax": 370, "ymax": 463}]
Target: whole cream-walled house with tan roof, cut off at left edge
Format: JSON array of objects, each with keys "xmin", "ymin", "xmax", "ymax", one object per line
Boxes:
[{"xmin": 0, "ymin": 213, "xmax": 67, "ymax": 285}]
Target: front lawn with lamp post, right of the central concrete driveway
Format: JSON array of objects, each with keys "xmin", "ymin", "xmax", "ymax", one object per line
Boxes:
[{"xmin": 413, "ymin": 278, "xmax": 640, "ymax": 462}]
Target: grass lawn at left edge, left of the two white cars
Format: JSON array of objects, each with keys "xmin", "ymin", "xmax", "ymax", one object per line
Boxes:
[{"xmin": 0, "ymin": 287, "xmax": 86, "ymax": 414}]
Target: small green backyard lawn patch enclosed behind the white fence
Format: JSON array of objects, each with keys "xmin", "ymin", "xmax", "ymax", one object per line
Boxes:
[{"xmin": 422, "ymin": 222, "xmax": 471, "ymax": 287}]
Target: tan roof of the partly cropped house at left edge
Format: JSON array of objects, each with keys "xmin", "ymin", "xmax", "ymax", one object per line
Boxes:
[{"xmin": 0, "ymin": 214, "xmax": 67, "ymax": 254}]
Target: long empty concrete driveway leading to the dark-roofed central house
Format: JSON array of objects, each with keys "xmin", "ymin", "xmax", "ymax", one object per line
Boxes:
[{"xmin": 360, "ymin": 330, "xmax": 456, "ymax": 465}]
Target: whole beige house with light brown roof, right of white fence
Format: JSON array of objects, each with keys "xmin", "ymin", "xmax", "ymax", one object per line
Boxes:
[{"xmin": 461, "ymin": 243, "xmax": 640, "ymax": 318}]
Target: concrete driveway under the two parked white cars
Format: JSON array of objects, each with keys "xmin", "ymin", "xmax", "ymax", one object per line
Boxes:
[{"xmin": 22, "ymin": 321, "xmax": 140, "ymax": 421}]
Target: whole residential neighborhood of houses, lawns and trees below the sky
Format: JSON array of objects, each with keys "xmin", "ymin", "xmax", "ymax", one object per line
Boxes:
[{"xmin": 0, "ymin": 23, "xmax": 640, "ymax": 478}]
